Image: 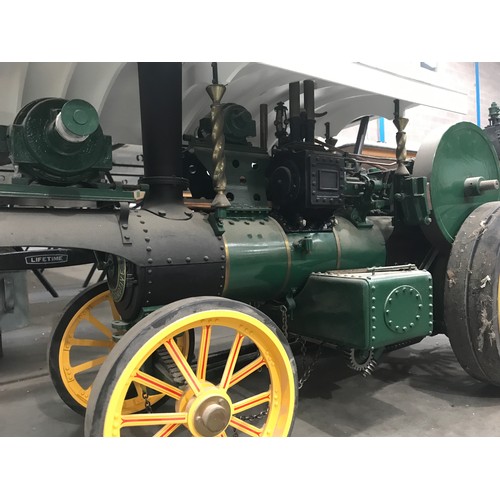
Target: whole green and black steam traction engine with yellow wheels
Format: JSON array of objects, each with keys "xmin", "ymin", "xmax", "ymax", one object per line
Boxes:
[{"xmin": 0, "ymin": 63, "xmax": 500, "ymax": 436}]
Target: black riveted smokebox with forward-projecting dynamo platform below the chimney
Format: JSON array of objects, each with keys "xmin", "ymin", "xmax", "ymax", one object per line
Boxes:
[{"xmin": 0, "ymin": 205, "xmax": 226, "ymax": 321}]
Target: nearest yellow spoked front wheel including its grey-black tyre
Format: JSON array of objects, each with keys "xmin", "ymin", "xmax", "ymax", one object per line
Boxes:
[{"xmin": 85, "ymin": 297, "xmax": 298, "ymax": 437}]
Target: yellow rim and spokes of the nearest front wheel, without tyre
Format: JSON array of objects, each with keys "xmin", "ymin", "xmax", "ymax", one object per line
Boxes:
[{"xmin": 103, "ymin": 310, "xmax": 295, "ymax": 437}]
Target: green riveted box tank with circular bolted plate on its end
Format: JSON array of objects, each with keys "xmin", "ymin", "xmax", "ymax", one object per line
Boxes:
[{"xmin": 289, "ymin": 267, "xmax": 433, "ymax": 349}]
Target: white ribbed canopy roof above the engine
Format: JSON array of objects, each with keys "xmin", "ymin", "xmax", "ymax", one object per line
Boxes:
[{"xmin": 0, "ymin": 62, "xmax": 466, "ymax": 150}]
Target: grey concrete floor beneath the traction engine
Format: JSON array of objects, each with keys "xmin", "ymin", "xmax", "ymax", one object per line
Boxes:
[{"xmin": 0, "ymin": 266, "xmax": 500, "ymax": 437}]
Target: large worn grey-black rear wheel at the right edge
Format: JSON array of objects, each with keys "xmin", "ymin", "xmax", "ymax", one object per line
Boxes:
[{"xmin": 444, "ymin": 202, "xmax": 500, "ymax": 386}]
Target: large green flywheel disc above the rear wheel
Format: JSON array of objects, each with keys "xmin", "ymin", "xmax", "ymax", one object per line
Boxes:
[{"xmin": 413, "ymin": 122, "xmax": 500, "ymax": 246}]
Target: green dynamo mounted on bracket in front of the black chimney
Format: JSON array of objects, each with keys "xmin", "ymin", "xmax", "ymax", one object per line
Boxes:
[{"xmin": 0, "ymin": 98, "xmax": 145, "ymax": 202}]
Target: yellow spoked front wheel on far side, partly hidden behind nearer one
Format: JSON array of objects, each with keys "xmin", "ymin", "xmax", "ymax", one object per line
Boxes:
[{"xmin": 48, "ymin": 282, "xmax": 190, "ymax": 415}]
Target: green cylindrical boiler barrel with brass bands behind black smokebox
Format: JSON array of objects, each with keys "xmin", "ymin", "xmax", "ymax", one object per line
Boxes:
[{"xmin": 223, "ymin": 217, "xmax": 385, "ymax": 300}]
